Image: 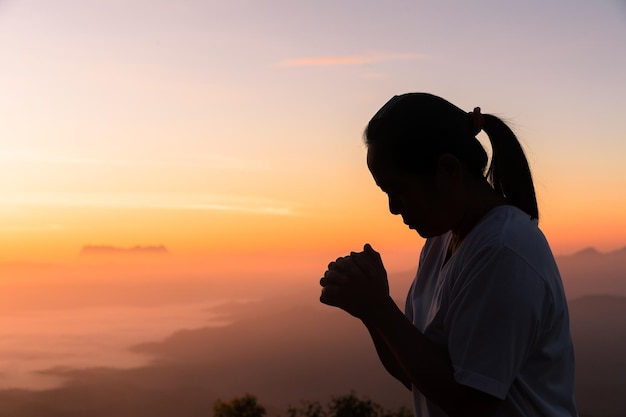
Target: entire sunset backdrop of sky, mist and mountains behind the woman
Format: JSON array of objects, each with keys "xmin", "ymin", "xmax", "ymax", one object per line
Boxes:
[{"xmin": 0, "ymin": 0, "xmax": 626, "ymax": 416}]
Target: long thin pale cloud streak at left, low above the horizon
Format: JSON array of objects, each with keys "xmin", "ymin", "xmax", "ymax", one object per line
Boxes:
[{"xmin": 0, "ymin": 192, "xmax": 300, "ymax": 216}]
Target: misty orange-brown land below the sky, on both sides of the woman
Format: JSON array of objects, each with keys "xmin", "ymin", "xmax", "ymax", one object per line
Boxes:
[{"xmin": 0, "ymin": 248, "xmax": 626, "ymax": 417}]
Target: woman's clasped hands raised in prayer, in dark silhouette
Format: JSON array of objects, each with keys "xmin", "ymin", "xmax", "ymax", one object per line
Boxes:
[{"xmin": 320, "ymin": 244, "xmax": 390, "ymax": 319}]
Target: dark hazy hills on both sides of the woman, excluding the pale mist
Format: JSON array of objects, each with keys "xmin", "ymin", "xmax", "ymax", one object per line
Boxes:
[{"xmin": 0, "ymin": 250, "xmax": 626, "ymax": 417}]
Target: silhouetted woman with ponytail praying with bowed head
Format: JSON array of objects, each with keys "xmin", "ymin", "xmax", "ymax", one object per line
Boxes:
[{"xmin": 320, "ymin": 93, "xmax": 577, "ymax": 417}]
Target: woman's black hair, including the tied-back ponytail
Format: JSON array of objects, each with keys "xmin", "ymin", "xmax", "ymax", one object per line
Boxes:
[{"xmin": 363, "ymin": 93, "xmax": 539, "ymax": 219}]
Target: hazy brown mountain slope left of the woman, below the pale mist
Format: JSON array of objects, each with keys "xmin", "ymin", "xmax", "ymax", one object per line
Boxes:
[{"xmin": 0, "ymin": 297, "xmax": 411, "ymax": 417}]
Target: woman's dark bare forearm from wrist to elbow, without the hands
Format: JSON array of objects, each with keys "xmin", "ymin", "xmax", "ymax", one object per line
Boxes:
[{"xmin": 363, "ymin": 299, "xmax": 500, "ymax": 417}]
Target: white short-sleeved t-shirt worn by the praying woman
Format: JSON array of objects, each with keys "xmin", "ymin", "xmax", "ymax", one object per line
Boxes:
[{"xmin": 406, "ymin": 205, "xmax": 577, "ymax": 417}]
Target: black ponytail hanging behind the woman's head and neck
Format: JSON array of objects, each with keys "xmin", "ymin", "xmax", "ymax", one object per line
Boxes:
[{"xmin": 482, "ymin": 114, "xmax": 539, "ymax": 220}]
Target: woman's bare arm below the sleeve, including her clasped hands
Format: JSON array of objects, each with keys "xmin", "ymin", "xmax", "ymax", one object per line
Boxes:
[{"xmin": 320, "ymin": 245, "xmax": 501, "ymax": 417}]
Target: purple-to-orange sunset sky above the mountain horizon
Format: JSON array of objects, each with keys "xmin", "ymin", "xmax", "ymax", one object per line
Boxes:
[{"xmin": 0, "ymin": 0, "xmax": 626, "ymax": 262}]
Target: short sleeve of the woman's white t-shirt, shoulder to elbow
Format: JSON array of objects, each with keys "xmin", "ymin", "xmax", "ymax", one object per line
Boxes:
[{"xmin": 444, "ymin": 247, "xmax": 547, "ymax": 399}]
